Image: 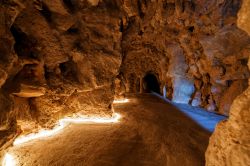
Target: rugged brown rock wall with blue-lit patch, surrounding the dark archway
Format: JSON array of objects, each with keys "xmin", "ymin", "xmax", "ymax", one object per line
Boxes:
[{"xmin": 120, "ymin": 0, "xmax": 250, "ymax": 115}]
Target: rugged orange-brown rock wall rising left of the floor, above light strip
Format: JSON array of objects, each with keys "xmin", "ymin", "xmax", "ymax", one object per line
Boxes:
[{"xmin": 0, "ymin": 0, "xmax": 122, "ymax": 150}]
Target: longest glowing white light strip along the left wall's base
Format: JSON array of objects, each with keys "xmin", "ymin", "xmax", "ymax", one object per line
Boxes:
[{"xmin": 13, "ymin": 113, "xmax": 121, "ymax": 145}]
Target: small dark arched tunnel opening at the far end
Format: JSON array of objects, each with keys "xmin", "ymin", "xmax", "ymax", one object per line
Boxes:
[{"xmin": 143, "ymin": 73, "xmax": 160, "ymax": 93}]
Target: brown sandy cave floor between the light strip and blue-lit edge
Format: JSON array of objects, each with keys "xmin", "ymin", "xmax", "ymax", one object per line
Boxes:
[{"xmin": 8, "ymin": 94, "xmax": 225, "ymax": 166}]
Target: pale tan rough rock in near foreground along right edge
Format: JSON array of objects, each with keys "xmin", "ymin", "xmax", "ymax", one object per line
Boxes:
[{"xmin": 206, "ymin": 0, "xmax": 250, "ymax": 166}]
